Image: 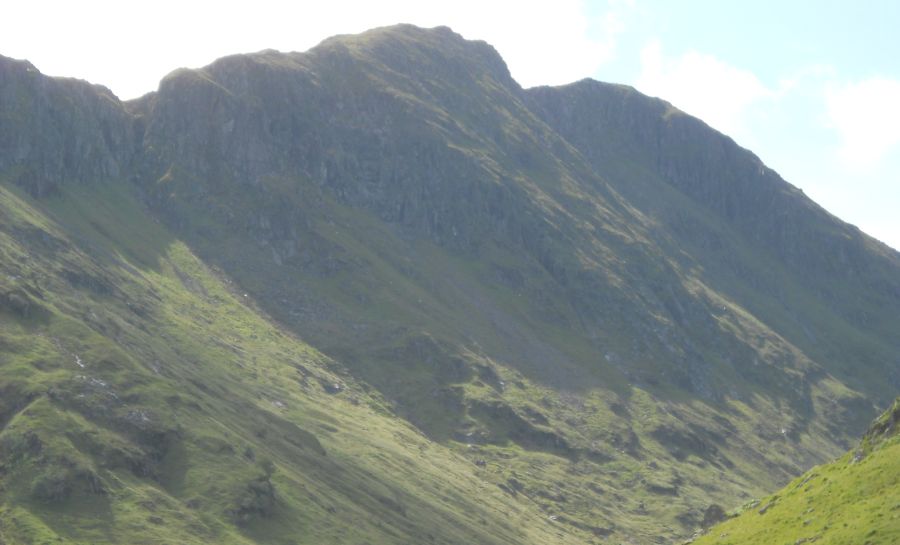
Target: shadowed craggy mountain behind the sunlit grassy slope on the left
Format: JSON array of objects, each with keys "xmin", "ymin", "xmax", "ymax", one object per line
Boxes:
[{"xmin": 0, "ymin": 26, "xmax": 900, "ymax": 539}]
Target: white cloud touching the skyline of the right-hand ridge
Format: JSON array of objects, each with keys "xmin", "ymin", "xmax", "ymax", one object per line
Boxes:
[{"xmin": 635, "ymin": 41, "xmax": 777, "ymax": 136}]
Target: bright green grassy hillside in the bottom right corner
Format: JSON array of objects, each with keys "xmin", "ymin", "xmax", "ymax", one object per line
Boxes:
[{"xmin": 695, "ymin": 399, "xmax": 900, "ymax": 545}]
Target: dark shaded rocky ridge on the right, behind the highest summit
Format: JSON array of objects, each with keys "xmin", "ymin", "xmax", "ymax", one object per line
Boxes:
[{"xmin": 528, "ymin": 81, "xmax": 900, "ymax": 396}]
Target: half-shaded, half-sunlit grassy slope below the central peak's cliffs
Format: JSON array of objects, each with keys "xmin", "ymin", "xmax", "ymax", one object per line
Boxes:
[{"xmin": 151, "ymin": 162, "xmax": 868, "ymax": 541}]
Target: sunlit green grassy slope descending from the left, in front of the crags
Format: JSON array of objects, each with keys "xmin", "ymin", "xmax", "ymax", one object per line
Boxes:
[{"xmin": 0, "ymin": 180, "xmax": 578, "ymax": 544}]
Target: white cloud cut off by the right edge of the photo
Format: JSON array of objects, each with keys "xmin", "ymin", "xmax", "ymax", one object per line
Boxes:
[{"xmin": 825, "ymin": 78, "xmax": 900, "ymax": 167}]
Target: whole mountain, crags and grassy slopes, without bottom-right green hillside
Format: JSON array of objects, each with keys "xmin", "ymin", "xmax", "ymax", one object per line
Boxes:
[{"xmin": 0, "ymin": 25, "xmax": 900, "ymax": 544}]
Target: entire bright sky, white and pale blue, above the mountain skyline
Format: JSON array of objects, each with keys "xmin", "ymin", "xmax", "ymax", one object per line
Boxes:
[{"xmin": 0, "ymin": 0, "xmax": 900, "ymax": 248}]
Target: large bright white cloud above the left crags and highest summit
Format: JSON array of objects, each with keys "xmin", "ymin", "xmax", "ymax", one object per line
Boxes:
[{"xmin": 0, "ymin": 0, "xmax": 631, "ymax": 98}]
